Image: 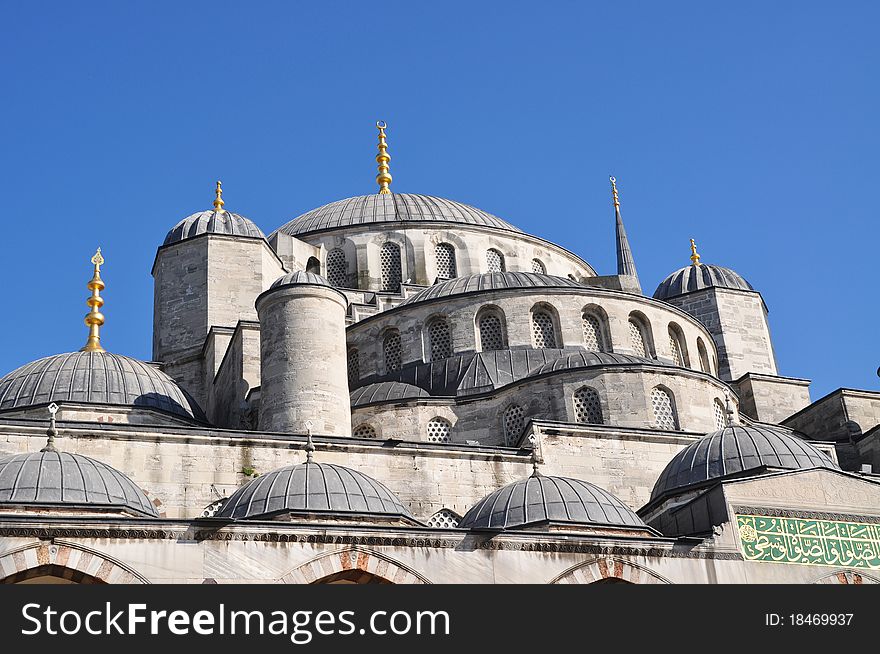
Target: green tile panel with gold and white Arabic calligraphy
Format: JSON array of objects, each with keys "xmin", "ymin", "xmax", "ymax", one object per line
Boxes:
[{"xmin": 736, "ymin": 514, "xmax": 880, "ymax": 569}]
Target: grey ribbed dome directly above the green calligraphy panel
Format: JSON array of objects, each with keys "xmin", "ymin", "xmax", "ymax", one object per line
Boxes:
[{"xmin": 651, "ymin": 425, "xmax": 837, "ymax": 501}]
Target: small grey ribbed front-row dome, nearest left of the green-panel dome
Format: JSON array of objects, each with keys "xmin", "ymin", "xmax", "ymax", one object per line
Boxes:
[{"xmin": 458, "ymin": 475, "xmax": 646, "ymax": 529}]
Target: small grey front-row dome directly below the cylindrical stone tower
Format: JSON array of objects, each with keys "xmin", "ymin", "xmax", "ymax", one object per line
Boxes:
[{"xmin": 216, "ymin": 461, "xmax": 412, "ymax": 520}]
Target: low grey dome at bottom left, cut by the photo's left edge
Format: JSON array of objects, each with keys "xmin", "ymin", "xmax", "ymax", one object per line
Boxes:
[{"xmin": 0, "ymin": 452, "xmax": 159, "ymax": 518}]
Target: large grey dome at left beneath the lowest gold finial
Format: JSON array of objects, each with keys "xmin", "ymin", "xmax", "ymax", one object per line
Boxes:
[{"xmin": 0, "ymin": 351, "xmax": 205, "ymax": 422}]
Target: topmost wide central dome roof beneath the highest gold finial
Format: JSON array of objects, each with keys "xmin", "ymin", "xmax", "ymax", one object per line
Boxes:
[{"xmin": 277, "ymin": 193, "xmax": 521, "ymax": 236}]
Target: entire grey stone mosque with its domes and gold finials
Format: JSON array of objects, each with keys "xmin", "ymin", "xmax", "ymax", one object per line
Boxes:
[{"xmin": 0, "ymin": 122, "xmax": 880, "ymax": 584}]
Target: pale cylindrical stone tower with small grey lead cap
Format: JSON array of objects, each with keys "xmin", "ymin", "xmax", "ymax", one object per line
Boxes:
[{"xmin": 256, "ymin": 271, "xmax": 351, "ymax": 436}]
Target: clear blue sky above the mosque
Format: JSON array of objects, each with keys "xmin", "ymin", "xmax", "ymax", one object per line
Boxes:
[{"xmin": 0, "ymin": 0, "xmax": 880, "ymax": 398}]
